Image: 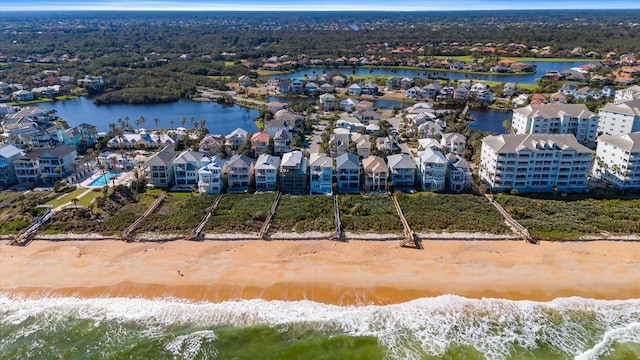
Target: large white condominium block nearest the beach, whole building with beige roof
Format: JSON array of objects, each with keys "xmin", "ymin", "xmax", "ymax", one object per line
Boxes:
[{"xmin": 479, "ymin": 134, "xmax": 592, "ymax": 192}]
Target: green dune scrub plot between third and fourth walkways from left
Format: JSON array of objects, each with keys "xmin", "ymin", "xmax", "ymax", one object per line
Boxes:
[{"xmin": 205, "ymin": 193, "xmax": 276, "ymax": 233}]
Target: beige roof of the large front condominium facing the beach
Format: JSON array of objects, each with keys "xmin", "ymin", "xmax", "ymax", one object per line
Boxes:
[{"xmin": 482, "ymin": 134, "xmax": 592, "ymax": 153}]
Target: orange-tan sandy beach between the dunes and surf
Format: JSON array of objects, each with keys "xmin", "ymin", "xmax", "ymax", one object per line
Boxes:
[{"xmin": 0, "ymin": 240, "xmax": 640, "ymax": 305}]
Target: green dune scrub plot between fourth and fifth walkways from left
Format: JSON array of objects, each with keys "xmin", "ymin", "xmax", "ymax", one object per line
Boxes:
[{"xmin": 270, "ymin": 195, "xmax": 335, "ymax": 233}]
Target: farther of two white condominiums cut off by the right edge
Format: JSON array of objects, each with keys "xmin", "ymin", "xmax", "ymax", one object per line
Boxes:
[{"xmin": 598, "ymin": 98, "xmax": 640, "ymax": 136}]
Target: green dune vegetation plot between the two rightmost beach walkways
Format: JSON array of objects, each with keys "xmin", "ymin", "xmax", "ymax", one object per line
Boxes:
[{"xmin": 398, "ymin": 193, "xmax": 510, "ymax": 234}]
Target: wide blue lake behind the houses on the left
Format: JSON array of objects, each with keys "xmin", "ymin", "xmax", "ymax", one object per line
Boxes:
[{"xmin": 37, "ymin": 97, "xmax": 259, "ymax": 134}]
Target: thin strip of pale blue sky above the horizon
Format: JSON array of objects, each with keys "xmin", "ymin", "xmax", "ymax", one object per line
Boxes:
[{"xmin": 0, "ymin": 0, "xmax": 640, "ymax": 11}]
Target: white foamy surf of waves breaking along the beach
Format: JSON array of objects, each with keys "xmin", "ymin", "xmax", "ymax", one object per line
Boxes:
[{"xmin": 0, "ymin": 295, "xmax": 640, "ymax": 360}]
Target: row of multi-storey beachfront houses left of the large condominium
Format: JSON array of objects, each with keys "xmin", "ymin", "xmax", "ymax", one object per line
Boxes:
[{"xmin": 142, "ymin": 145, "xmax": 471, "ymax": 195}]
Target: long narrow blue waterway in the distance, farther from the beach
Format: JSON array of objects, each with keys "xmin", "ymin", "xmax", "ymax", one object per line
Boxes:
[{"xmin": 268, "ymin": 61, "xmax": 590, "ymax": 84}]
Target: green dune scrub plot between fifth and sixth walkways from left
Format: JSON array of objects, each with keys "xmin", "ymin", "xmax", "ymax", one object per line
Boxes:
[{"xmin": 338, "ymin": 195, "xmax": 403, "ymax": 233}]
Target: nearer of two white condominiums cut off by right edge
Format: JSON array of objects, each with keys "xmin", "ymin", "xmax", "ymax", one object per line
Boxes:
[{"xmin": 592, "ymin": 132, "xmax": 640, "ymax": 189}]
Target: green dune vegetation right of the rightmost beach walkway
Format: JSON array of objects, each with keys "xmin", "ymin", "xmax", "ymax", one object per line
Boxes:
[{"xmin": 494, "ymin": 194, "xmax": 640, "ymax": 240}]
